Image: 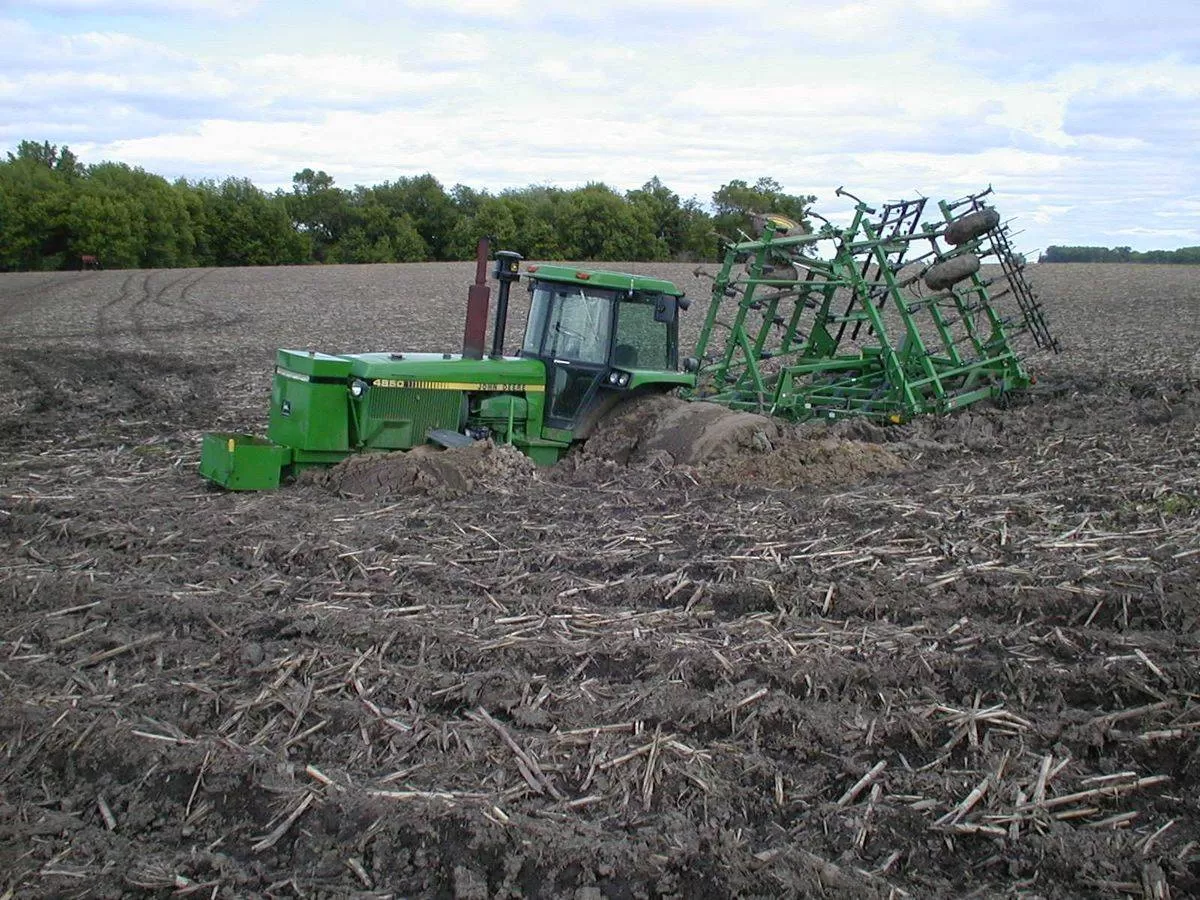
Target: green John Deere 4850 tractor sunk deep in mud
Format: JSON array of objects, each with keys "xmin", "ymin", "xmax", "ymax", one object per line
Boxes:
[{"xmin": 200, "ymin": 240, "xmax": 695, "ymax": 491}]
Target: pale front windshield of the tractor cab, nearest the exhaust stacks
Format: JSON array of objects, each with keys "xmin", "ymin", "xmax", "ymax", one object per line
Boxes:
[{"xmin": 522, "ymin": 282, "xmax": 613, "ymax": 365}]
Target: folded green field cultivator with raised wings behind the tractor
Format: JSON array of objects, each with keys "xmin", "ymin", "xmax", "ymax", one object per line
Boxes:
[{"xmin": 694, "ymin": 188, "xmax": 1057, "ymax": 422}]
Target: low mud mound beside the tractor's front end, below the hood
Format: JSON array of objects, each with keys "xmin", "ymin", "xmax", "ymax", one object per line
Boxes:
[{"xmin": 307, "ymin": 440, "xmax": 535, "ymax": 499}]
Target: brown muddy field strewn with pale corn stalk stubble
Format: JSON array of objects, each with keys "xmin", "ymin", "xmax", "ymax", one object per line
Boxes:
[{"xmin": 0, "ymin": 264, "xmax": 1200, "ymax": 899}]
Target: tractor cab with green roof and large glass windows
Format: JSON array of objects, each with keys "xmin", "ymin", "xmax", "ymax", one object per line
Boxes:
[{"xmin": 521, "ymin": 265, "xmax": 694, "ymax": 439}]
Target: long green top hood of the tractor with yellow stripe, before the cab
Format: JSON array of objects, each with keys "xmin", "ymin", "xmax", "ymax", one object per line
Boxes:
[{"xmin": 276, "ymin": 350, "xmax": 546, "ymax": 391}]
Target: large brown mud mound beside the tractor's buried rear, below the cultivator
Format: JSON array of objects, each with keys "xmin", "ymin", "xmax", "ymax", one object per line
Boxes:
[{"xmin": 568, "ymin": 396, "xmax": 905, "ymax": 487}]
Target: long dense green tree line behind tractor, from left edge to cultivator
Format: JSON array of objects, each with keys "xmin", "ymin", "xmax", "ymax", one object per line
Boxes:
[{"xmin": 0, "ymin": 140, "xmax": 815, "ymax": 271}]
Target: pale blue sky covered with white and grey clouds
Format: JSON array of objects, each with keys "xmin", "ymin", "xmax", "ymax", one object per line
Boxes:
[{"xmin": 0, "ymin": 0, "xmax": 1200, "ymax": 253}]
